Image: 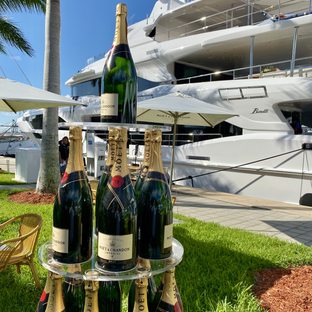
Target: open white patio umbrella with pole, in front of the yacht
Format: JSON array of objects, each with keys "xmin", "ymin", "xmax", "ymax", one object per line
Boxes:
[{"xmin": 137, "ymin": 92, "xmax": 237, "ymax": 187}]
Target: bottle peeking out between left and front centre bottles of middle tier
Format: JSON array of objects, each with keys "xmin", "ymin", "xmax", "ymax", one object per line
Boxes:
[{"xmin": 95, "ymin": 128, "xmax": 117, "ymax": 233}]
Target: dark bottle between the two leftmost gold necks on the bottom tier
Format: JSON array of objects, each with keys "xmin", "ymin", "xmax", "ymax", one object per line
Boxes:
[{"xmin": 63, "ymin": 264, "xmax": 85, "ymax": 312}]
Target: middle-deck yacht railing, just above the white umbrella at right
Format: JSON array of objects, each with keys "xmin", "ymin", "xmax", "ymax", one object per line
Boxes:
[{"xmin": 172, "ymin": 57, "xmax": 312, "ymax": 84}]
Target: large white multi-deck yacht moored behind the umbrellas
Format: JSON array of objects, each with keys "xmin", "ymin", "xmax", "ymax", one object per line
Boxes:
[{"xmin": 18, "ymin": 0, "xmax": 312, "ymax": 205}]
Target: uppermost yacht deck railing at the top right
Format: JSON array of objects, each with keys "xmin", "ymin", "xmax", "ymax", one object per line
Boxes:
[{"xmin": 161, "ymin": 0, "xmax": 312, "ymax": 40}]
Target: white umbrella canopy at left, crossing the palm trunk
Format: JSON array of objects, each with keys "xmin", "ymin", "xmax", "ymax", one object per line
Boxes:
[{"xmin": 0, "ymin": 78, "xmax": 81, "ymax": 113}]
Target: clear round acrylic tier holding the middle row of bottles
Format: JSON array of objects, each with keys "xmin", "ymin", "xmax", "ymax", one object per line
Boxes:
[{"xmin": 39, "ymin": 239, "xmax": 184, "ymax": 281}]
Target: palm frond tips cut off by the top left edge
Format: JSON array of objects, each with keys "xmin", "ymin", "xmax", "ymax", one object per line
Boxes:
[{"xmin": 0, "ymin": 0, "xmax": 46, "ymax": 12}]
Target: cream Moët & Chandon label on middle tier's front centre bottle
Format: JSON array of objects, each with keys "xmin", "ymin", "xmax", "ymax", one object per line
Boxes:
[{"xmin": 98, "ymin": 232, "xmax": 133, "ymax": 261}]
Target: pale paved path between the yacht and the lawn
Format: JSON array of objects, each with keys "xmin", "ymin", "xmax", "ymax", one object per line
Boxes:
[{"xmin": 173, "ymin": 187, "xmax": 312, "ymax": 246}]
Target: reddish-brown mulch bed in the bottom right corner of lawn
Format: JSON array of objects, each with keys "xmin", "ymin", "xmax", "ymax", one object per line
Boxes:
[{"xmin": 254, "ymin": 266, "xmax": 312, "ymax": 312}]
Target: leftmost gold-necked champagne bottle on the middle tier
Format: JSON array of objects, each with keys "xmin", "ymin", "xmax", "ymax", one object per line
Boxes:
[{"xmin": 52, "ymin": 127, "xmax": 93, "ymax": 263}]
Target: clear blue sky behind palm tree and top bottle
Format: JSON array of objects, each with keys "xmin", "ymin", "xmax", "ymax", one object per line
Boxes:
[{"xmin": 0, "ymin": 0, "xmax": 156, "ymax": 124}]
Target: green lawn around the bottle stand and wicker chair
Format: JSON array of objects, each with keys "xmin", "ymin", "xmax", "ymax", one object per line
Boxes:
[{"xmin": 0, "ymin": 186, "xmax": 312, "ymax": 312}]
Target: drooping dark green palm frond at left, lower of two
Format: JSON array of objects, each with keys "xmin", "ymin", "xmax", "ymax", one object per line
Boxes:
[{"xmin": 0, "ymin": 16, "xmax": 34, "ymax": 56}]
